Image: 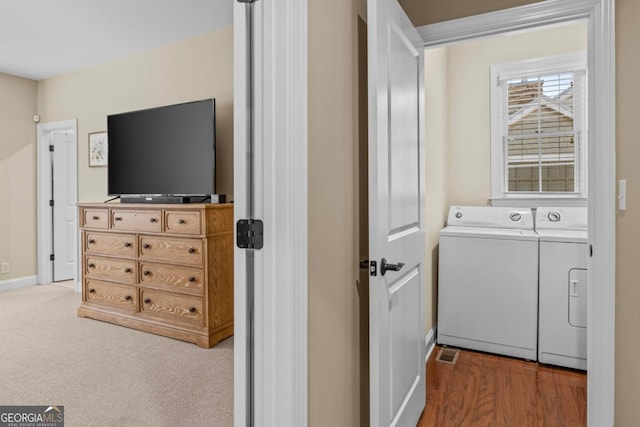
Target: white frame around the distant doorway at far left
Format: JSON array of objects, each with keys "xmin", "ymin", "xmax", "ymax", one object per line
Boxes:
[{"xmin": 36, "ymin": 119, "xmax": 80, "ymax": 292}]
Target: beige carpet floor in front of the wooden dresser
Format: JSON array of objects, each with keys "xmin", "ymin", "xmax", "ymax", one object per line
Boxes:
[{"xmin": 0, "ymin": 284, "xmax": 233, "ymax": 427}]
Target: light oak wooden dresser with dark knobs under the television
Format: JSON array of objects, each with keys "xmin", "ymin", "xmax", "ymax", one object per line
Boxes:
[{"xmin": 78, "ymin": 203, "xmax": 233, "ymax": 348}]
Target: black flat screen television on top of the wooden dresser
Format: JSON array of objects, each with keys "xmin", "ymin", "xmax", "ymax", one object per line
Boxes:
[{"xmin": 107, "ymin": 99, "xmax": 216, "ymax": 203}]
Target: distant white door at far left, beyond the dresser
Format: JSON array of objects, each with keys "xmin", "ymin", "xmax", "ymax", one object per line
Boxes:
[{"xmin": 49, "ymin": 129, "xmax": 78, "ymax": 282}]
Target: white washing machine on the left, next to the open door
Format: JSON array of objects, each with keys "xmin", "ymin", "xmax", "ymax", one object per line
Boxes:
[{"xmin": 437, "ymin": 206, "xmax": 538, "ymax": 360}]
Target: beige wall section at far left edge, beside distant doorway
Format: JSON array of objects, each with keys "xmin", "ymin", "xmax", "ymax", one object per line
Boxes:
[{"xmin": 0, "ymin": 73, "xmax": 37, "ymax": 281}]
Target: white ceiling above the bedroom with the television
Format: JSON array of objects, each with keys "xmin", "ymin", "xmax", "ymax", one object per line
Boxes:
[{"xmin": 0, "ymin": 0, "xmax": 234, "ymax": 80}]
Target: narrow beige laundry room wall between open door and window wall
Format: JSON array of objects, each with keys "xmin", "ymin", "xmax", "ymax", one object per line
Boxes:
[{"xmin": 424, "ymin": 47, "xmax": 451, "ymax": 335}]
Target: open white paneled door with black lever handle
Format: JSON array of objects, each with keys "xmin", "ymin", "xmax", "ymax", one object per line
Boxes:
[{"xmin": 367, "ymin": 0, "xmax": 426, "ymax": 427}]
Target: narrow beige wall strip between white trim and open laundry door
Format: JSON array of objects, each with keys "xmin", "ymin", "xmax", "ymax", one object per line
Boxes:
[{"xmin": 309, "ymin": 0, "xmax": 360, "ymax": 427}]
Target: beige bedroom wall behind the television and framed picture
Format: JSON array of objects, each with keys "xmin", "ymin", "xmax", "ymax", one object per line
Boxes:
[{"xmin": 38, "ymin": 27, "xmax": 233, "ymax": 202}]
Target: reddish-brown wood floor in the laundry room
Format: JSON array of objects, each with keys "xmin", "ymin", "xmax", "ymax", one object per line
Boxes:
[{"xmin": 418, "ymin": 346, "xmax": 587, "ymax": 427}]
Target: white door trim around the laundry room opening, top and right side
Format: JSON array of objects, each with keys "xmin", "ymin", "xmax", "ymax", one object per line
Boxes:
[{"xmin": 418, "ymin": 0, "xmax": 616, "ymax": 427}]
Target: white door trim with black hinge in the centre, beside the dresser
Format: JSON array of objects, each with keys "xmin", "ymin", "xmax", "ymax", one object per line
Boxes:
[{"xmin": 234, "ymin": 0, "xmax": 308, "ymax": 427}]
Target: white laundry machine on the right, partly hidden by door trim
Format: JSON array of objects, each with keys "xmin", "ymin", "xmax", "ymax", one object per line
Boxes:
[{"xmin": 536, "ymin": 207, "xmax": 588, "ymax": 370}]
